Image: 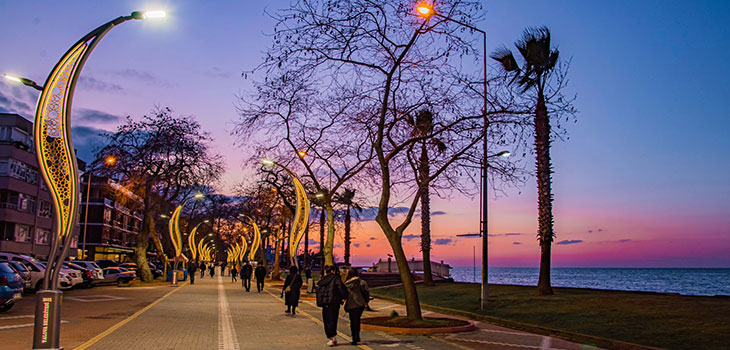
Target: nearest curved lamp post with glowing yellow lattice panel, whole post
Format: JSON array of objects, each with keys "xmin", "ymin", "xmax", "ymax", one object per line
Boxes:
[{"xmin": 5, "ymin": 11, "xmax": 165, "ymax": 349}]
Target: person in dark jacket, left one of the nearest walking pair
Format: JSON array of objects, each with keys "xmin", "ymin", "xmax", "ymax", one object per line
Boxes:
[{"xmin": 317, "ymin": 265, "xmax": 347, "ymax": 346}]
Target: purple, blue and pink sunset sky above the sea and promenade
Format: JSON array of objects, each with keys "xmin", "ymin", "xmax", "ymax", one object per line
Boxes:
[{"xmin": 0, "ymin": 0, "xmax": 730, "ymax": 268}]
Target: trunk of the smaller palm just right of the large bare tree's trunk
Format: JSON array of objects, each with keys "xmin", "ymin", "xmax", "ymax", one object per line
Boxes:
[{"xmin": 418, "ymin": 142, "xmax": 434, "ymax": 286}]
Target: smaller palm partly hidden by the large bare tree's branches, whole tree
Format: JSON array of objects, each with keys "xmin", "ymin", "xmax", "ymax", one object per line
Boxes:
[{"xmin": 409, "ymin": 109, "xmax": 446, "ymax": 286}]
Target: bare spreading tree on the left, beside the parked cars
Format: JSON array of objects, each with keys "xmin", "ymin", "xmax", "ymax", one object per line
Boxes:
[{"xmin": 96, "ymin": 108, "xmax": 223, "ymax": 282}]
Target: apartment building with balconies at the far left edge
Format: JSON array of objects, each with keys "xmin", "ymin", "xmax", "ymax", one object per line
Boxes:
[{"xmin": 0, "ymin": 113, "xmax": 86, "ymax": 259}]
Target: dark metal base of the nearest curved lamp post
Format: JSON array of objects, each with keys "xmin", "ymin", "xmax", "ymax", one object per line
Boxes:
[{"xmin": 33, "ymin": 290, "xmax": 63, "ymax": 350}]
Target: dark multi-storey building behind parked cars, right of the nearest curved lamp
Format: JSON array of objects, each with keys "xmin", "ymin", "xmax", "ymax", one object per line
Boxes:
[{"xmin": 79, "ymin": 174, "xmax": 143, "ymax": 262}]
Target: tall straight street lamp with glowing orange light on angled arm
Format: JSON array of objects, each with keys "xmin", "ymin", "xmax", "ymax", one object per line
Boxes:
[{"xmin": 416, "ymin": 2, "xmax": 490, "ymax": 311}]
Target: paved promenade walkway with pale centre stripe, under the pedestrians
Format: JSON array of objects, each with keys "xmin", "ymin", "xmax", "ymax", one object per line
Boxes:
[{"xmin": 71, "ymin": 276, "xmax": 595, "ymax": 350}]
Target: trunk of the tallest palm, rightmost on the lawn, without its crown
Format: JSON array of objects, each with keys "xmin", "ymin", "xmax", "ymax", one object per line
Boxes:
[{"xmin": 535, "ymin": 89, "xmax": 554, "ymax": 295}]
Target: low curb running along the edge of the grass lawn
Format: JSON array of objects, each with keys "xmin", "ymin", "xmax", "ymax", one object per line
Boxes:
[{"xmin": 372, "ymin": 294, "xmax": 664, "ymax": 350}]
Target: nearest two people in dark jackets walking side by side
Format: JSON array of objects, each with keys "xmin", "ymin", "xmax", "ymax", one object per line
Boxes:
[{"xmin": 314, "ymin": 265, "xmax": 370, "ymax": 346}]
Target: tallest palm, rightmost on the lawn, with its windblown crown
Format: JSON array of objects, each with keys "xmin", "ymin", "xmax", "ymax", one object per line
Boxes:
[{"xmin": 492, "ymin": 27, "xmax": 559, "ymax": 295}]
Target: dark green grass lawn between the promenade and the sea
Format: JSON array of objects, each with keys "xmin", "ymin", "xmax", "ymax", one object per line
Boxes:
[{"xmin": 371, "ymin": 283, "xmax": 730, "ymax": 350}]
